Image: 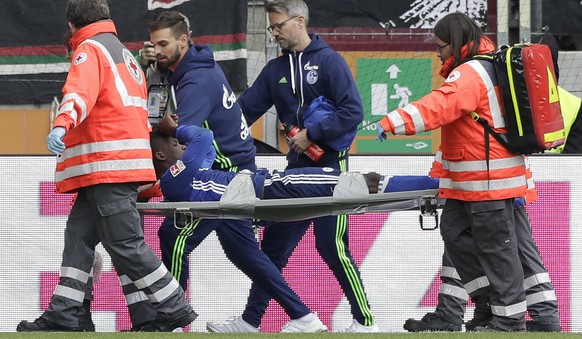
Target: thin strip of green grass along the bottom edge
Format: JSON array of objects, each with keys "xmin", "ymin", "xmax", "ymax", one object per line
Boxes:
[{"xmin": 0, "ymin": 332, "xmax": 582, "ymax": 339}]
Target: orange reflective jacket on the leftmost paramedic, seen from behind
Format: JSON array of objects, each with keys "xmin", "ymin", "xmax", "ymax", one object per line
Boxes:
[{"xmin": 53, "ymin": 20, "xmax": 156, "ymax": 193}]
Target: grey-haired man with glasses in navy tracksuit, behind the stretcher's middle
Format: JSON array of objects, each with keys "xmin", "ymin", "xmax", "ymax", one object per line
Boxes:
[{"xmin": 207, "ymin": 0, "xmax": 378, "ymax": 332}]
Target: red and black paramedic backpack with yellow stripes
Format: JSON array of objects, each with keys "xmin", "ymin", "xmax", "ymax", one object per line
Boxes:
[{"xmin": 473, "ymin": 44, "xmax": 566, "ymax": 154}]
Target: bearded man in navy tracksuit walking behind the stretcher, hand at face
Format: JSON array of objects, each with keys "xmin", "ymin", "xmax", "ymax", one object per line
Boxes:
[{"xmin": 126, "ymin": 11, "xmax": 327, "ymax": 332}]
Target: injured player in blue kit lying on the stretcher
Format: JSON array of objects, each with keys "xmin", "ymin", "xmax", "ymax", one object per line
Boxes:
[{"xmin": 150, "ymin": 115, "xmax": 438, "ymax": 202}]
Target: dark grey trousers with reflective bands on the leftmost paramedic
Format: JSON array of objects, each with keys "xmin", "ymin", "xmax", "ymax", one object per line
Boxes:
[{"xmin": 42, "ymin": 183, "xmax": 191, "ymax": 327}]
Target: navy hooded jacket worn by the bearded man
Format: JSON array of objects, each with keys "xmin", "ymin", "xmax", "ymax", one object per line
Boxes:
[{"xmin": 168, "ymin": 45, "xmax": 256, "ymax": 171}]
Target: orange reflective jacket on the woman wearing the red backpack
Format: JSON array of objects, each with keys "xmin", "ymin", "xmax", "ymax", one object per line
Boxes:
[{"xmin": 380, "ymin": 40, "xmax": 527, "ymax": 201}]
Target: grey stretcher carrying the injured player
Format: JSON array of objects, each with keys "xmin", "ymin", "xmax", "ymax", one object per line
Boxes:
[{"xmin": 137, "ymin": 173, "xmax": 444, "ymax": 229}]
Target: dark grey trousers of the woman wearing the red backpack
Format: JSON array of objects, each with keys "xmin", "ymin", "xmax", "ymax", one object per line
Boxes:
[{"xmin": 441, "ymin": 199, "xmax": 526, "ymax": 330}]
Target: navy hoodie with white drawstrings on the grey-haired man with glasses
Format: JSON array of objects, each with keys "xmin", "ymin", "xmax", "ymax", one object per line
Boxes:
[{"xmin": 238, "ymin": 34, "xmax": 364, "ymax": 170}]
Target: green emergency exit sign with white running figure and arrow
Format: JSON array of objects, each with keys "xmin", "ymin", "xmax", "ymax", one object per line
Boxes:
[{"xmin": 356, "ymin": 58, "xmax": 432, "ymax": 153}]
